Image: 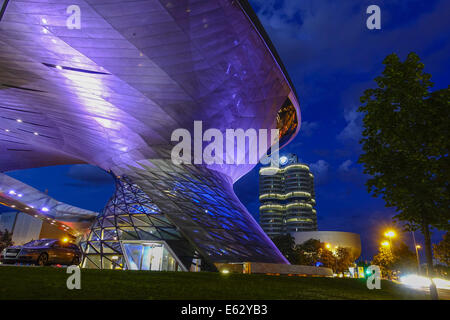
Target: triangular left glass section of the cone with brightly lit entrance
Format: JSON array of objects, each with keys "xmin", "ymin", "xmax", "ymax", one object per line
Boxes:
[{"xmin": 81, "ymin": 177, "xmax": 196, "ymax": 271}]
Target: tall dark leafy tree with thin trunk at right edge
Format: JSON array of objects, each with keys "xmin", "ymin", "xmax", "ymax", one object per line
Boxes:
[{"xmin": 358, "ymin": 53, "xmax": 450, "ymax": 298}]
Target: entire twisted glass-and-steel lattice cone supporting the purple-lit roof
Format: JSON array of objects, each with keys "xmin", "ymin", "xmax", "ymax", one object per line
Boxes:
[{"xmin": 81, "ymin": 165, "xmax": 286, "ymax": 271}]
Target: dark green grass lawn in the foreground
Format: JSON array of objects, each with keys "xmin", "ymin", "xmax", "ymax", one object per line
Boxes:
[{"xmin": 0, "ymin": 266, "xmax": 428, "ymax": 300}]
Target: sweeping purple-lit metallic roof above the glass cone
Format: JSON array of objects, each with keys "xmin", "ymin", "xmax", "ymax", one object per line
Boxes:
[{"xmin": 0, "ymin": 0, "xmax": 299, "ymax": 180}]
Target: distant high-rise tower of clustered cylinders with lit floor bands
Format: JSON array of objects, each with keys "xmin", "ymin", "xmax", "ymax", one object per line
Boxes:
[{"xmin": 259, "ymin": 154, "xmax": 317, "ymax": 237}]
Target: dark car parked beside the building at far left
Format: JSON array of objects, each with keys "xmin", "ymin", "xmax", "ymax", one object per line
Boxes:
[{"xmin": 0, "ymin": 239, "xmax": 81, "ymax": 266}]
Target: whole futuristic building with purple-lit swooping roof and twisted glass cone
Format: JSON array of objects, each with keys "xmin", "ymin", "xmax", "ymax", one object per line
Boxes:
[{"xmin": 0, "ymin": 0, "xmax": 300, "ymax": 270}]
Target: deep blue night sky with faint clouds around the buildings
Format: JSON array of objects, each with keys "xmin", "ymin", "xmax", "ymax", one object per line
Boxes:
[{"xmin": 3, "ymin": 0, "xmax": 450, "ymax": 259}]
